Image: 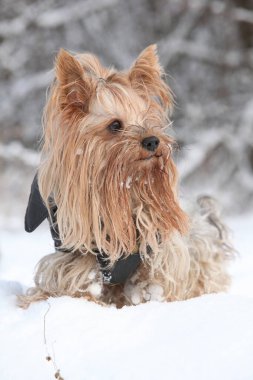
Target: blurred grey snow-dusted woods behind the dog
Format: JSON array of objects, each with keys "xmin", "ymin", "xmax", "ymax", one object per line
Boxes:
[{"xmin": 0, "ymin": 0, "xmax": 253, "ymax": 227}]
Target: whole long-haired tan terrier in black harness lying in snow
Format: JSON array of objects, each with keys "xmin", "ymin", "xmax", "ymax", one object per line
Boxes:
[{"xmin": 19, "ymin": 45, "xmax": 234, "ymax": 307}]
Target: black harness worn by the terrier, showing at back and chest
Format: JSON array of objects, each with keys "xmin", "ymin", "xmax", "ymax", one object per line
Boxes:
[{"xmin": 25, "ymin": 175, "xmax": 141, "ymax": 284}]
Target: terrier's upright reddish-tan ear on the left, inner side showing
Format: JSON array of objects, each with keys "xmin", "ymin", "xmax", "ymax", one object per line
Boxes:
[{"xmin": 55, "ymin": 49, "xmax": 91, "ymax": 111}]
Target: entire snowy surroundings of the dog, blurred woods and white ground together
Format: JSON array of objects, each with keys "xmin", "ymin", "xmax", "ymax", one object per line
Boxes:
[{"xmin": 0, "ymin": 0, "xmax": 253, "ymax": 380}]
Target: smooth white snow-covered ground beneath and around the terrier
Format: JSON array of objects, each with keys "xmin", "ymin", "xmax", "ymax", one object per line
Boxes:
[{"xmin": 0, "ymin": 216, "xmax": 253, "ymax": 380}]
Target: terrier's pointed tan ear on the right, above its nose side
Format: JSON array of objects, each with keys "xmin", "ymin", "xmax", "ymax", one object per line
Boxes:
[{"xmin": 129, "ymin": 45, "xmax": 173, "ymax": 109}]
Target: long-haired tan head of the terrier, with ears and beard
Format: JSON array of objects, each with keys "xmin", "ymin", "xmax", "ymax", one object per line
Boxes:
[{"xmin": 39, "ymin": 45, "xmax": 187, "ymax": 260}]
